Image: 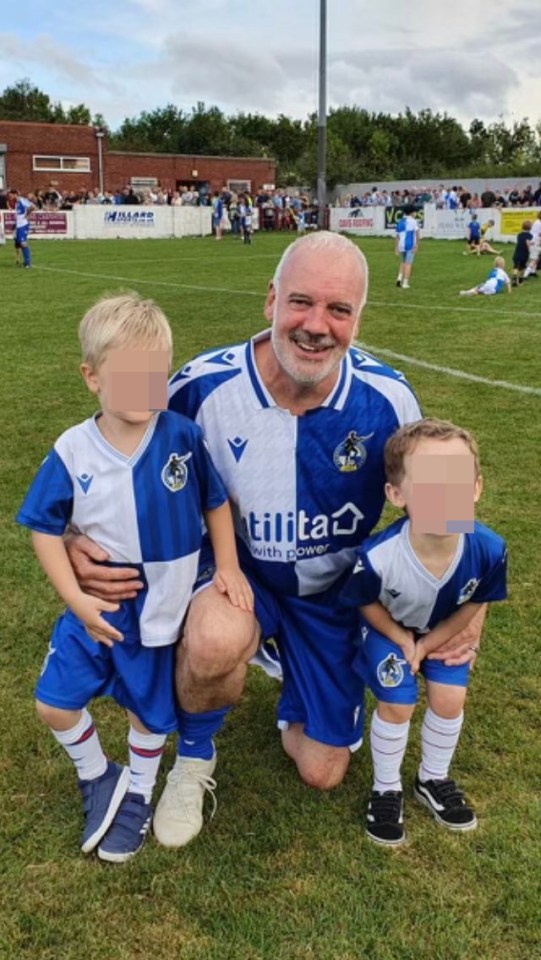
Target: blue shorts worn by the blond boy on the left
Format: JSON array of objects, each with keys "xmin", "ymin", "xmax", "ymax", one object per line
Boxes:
[{"xmin": 35, "ymin": 610, "xmax": 177, "ymax": 733}]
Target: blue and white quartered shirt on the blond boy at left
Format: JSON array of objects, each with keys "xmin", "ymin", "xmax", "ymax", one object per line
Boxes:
[{"xmin": 17, "ymin": 411, "xmax": 227, "ymax": 647}]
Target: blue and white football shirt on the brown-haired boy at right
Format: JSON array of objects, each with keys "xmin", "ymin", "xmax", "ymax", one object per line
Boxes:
[{"xmin": 340, "ymin": 517, "xmax": 507, "ymax": 634}]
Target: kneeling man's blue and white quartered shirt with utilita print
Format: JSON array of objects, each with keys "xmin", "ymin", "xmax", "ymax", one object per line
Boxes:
[{"xmin": 169, "ymin": 331, "xmax": 421, "ymax": 596}]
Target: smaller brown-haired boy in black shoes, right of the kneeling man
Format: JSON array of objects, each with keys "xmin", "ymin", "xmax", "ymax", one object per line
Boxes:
[{"xmin": 341, "ymin": 418, "xmax": 506, "ymax": 846}]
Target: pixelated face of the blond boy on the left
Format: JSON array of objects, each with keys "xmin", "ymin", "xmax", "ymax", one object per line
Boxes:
[{"xmin": 81, "ymin": 348, "xmax": 169, "ymax": 421}]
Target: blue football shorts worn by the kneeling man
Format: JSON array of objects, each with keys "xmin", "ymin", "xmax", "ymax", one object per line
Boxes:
[{"xmin": 194, "ymin": 553, "xmax": 364, "ymax": 750}]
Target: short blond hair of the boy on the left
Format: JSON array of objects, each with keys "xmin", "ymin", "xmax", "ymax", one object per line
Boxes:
[{"xmin": 79, "ymin": 293, "xmax": 173, "ymax": 370}]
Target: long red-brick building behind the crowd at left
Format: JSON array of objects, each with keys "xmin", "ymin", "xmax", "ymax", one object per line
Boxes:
[{"xmin": 0, "ymin": 120, "xmax": 276, "ymax": 200}]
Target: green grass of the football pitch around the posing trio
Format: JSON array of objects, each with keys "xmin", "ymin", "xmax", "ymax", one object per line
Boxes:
[{"xmin": 0, "ymin": 236, "xmax": 541, "ymax": 960}]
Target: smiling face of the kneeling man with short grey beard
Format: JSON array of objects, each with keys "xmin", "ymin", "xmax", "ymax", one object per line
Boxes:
[{"xmin": 265, "ymin": 249, "xmax": 365, "ymax": 384}]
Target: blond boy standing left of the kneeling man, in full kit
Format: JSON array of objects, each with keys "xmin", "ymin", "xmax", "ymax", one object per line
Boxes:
[{"xmin": 17, "ymin": 294, "xmax": 252, "ymax": 862}]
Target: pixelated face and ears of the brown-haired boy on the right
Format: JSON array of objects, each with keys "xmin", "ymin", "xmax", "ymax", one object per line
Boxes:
[{"xmin": 386, "ymin": 437, "xmax": 482, "ymax": 536}]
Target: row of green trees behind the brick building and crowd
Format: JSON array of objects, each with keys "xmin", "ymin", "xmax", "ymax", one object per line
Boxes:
[{"xmin": 0, "ymin": 79, "xmax": 541, "ymax": 189}]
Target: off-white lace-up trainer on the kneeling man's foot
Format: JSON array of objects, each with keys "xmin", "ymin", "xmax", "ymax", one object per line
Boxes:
[{"xmin": 152, "ymin": 753, "xmax": 218, "ymax": 847}]
